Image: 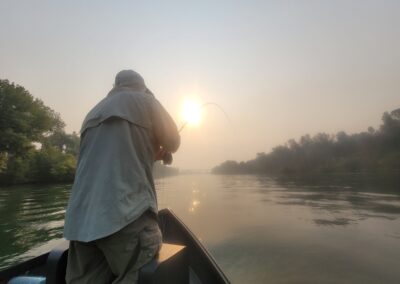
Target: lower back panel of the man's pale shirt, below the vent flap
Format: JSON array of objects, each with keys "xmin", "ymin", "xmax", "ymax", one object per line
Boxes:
[{"xmin": 65, "ymin": 118, "xmax": 157, "ymax": 242}]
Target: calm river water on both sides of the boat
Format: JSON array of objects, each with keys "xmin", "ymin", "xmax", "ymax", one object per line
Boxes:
[{"xmin": 0, "ymin": 174, "xmax": 400, "ymax": 283}]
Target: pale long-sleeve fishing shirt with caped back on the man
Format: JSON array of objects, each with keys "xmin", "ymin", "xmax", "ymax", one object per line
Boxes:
[{"xmin": 64, "ymin": 88, "xmax": 180, "ymax": 242}]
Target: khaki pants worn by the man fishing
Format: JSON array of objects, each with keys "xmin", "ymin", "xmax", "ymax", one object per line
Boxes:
[{"xmin": 66, "ymin": 213, "xmax": 162, "ymax": 284}]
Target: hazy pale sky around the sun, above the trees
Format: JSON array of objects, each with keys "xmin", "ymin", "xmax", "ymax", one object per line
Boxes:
[{"xmin": 0, "ymin": 0, "xmax": 400, "ymax": 169}]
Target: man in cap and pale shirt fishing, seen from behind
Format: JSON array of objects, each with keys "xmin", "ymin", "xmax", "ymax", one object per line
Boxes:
[{"xmin": 64, "ymin": 70, "xmax": 180, "ymax": 283}]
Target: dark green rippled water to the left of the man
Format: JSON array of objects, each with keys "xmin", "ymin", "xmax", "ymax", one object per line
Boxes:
[{"xmin": 0, "ymin": 185, "xmax": 70, "ymax": 268}]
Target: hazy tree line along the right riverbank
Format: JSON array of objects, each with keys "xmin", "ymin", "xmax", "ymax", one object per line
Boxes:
[{"xmin": 212, "ymin": 109, "xmax": 400, "ymax": 177}]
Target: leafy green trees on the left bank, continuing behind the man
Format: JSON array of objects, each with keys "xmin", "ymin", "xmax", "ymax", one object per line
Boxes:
[{"xmin": 0, "ymin": 79, "xmax": 179, "ymax": 185}]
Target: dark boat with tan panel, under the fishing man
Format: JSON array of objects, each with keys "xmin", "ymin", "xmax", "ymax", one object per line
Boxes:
[{"xmin": 0, "ymin": 209, "xmax": 230, "ymax": 284}]
